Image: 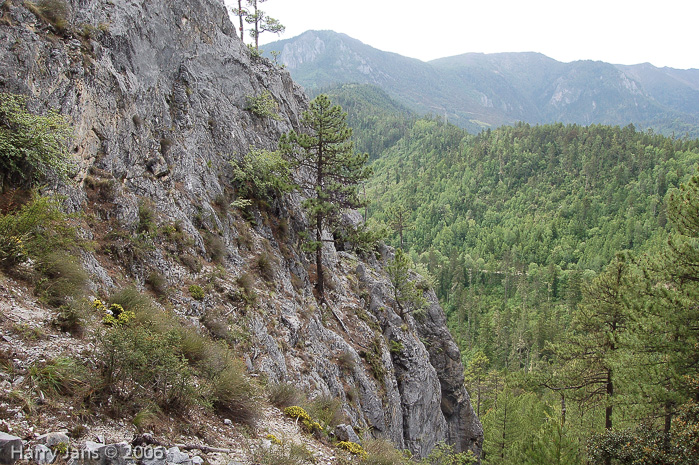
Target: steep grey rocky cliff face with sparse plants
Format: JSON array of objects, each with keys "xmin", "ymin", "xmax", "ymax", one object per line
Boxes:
[{"xmin": 0, "ymin": 0, "xmax": 482, "ymax": 455}]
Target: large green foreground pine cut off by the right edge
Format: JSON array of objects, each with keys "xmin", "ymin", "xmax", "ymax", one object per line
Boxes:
[{"xmin": 630, "ymin": 170, "xmax": 699, "ymax": 438}]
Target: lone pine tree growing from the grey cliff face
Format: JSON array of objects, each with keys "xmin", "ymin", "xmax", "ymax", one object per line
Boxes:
[{"xmin": 279, "ymin": 95, "xmax": 371, "ymax": 301}]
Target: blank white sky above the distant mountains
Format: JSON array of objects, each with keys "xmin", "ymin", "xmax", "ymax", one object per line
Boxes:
[{"xmin": 225, "ymin": 0, "xmax": 699, "ymax": 69}]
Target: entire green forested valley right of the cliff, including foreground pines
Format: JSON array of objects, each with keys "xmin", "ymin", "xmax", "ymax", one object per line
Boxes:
[{"xmin": 325, "ymin": 85, "xmax": 699, "ymax": 464}]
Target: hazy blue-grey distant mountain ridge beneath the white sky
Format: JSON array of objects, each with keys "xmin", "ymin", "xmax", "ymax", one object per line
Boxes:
[{"xmin": 264, "ymin": 31, "xmax": 699, "ymax": 137}]
